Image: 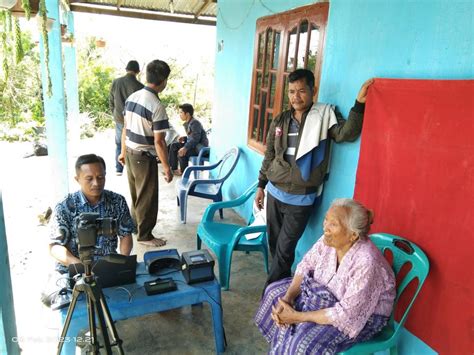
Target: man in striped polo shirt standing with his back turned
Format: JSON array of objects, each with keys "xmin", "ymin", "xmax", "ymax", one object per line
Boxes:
[{"xmin": 119, "ymin": 59, "xmax": 173, "ymax": 247}]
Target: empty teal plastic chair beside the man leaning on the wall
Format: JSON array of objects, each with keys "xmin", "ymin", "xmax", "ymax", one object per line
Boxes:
[{"xmin": 197, "ymin": 183, "xmax": 268, "ymax": 290}]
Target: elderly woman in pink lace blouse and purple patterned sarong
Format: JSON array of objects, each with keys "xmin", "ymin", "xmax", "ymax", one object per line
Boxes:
[{"xmin": 255, "ymin": 199, "xmax": 395, "ymax": 354}]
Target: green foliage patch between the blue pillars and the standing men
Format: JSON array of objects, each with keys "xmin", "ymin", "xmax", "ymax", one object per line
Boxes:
[{"xmin": 78, "ymin": 38, "xmax": 115, "ymax": 130}]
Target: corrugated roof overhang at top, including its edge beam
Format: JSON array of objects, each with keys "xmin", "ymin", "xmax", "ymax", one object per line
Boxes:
[{"xmin": 67, "ymin": 0, "xmax": 217, "ymax": 25}]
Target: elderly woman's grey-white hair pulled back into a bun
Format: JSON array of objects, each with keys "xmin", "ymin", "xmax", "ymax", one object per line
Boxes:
[{"xmin": 330, "ymin": 198, "xmax": 374, "ymax": 239}]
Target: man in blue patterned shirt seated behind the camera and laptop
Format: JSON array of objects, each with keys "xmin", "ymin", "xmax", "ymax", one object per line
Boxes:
[{"xmin": 42, "ymin": 154, "xmax": 135, "ymax": 305}]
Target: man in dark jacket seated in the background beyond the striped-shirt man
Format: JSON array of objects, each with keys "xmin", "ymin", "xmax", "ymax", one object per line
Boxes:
[{"xmin": 169, "ymin": 104, "xmax": 209, "ymax": 176}]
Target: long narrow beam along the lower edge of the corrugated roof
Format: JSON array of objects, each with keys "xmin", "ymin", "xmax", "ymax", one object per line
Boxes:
[{"xmin": 70, "ymin": 2, "xmax": 216, "ymax": 26}]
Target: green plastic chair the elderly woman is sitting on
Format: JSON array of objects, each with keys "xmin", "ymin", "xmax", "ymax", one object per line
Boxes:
[{"xmin": 339, "ymin": 233, "xmax": 430, "ymax": 355}]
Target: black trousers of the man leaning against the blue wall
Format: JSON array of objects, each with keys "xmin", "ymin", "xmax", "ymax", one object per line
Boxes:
[{"xmin": 265, "ymin": 193, "xmax": 314, "ymax": 287}]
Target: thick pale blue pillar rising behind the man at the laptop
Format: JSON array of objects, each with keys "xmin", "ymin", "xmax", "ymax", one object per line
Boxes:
[{"xmin": 40, "ymin": 0, "xmax": 69, "ymax": 201}]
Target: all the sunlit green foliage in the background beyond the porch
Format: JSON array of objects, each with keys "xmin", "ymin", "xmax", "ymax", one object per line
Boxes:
[{"xmin": 0, "ymin": 28, "xmax": 211, "ymax": 140}]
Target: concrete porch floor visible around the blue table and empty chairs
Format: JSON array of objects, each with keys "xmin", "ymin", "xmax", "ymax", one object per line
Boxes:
[{"xmin": 109, "ymin": 171, "xmax": 267, "ymax": 355}]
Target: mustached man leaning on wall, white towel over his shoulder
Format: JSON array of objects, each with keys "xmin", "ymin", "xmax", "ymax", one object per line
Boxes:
[{"xmin": 255, "ymin": 69, "xmax": 373, "ymax": 286}]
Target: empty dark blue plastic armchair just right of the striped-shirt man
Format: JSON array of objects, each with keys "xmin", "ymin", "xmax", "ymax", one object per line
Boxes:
[{"xmin": 176, "ymin": 147, "xmax": 240, "ymax": 223}]
